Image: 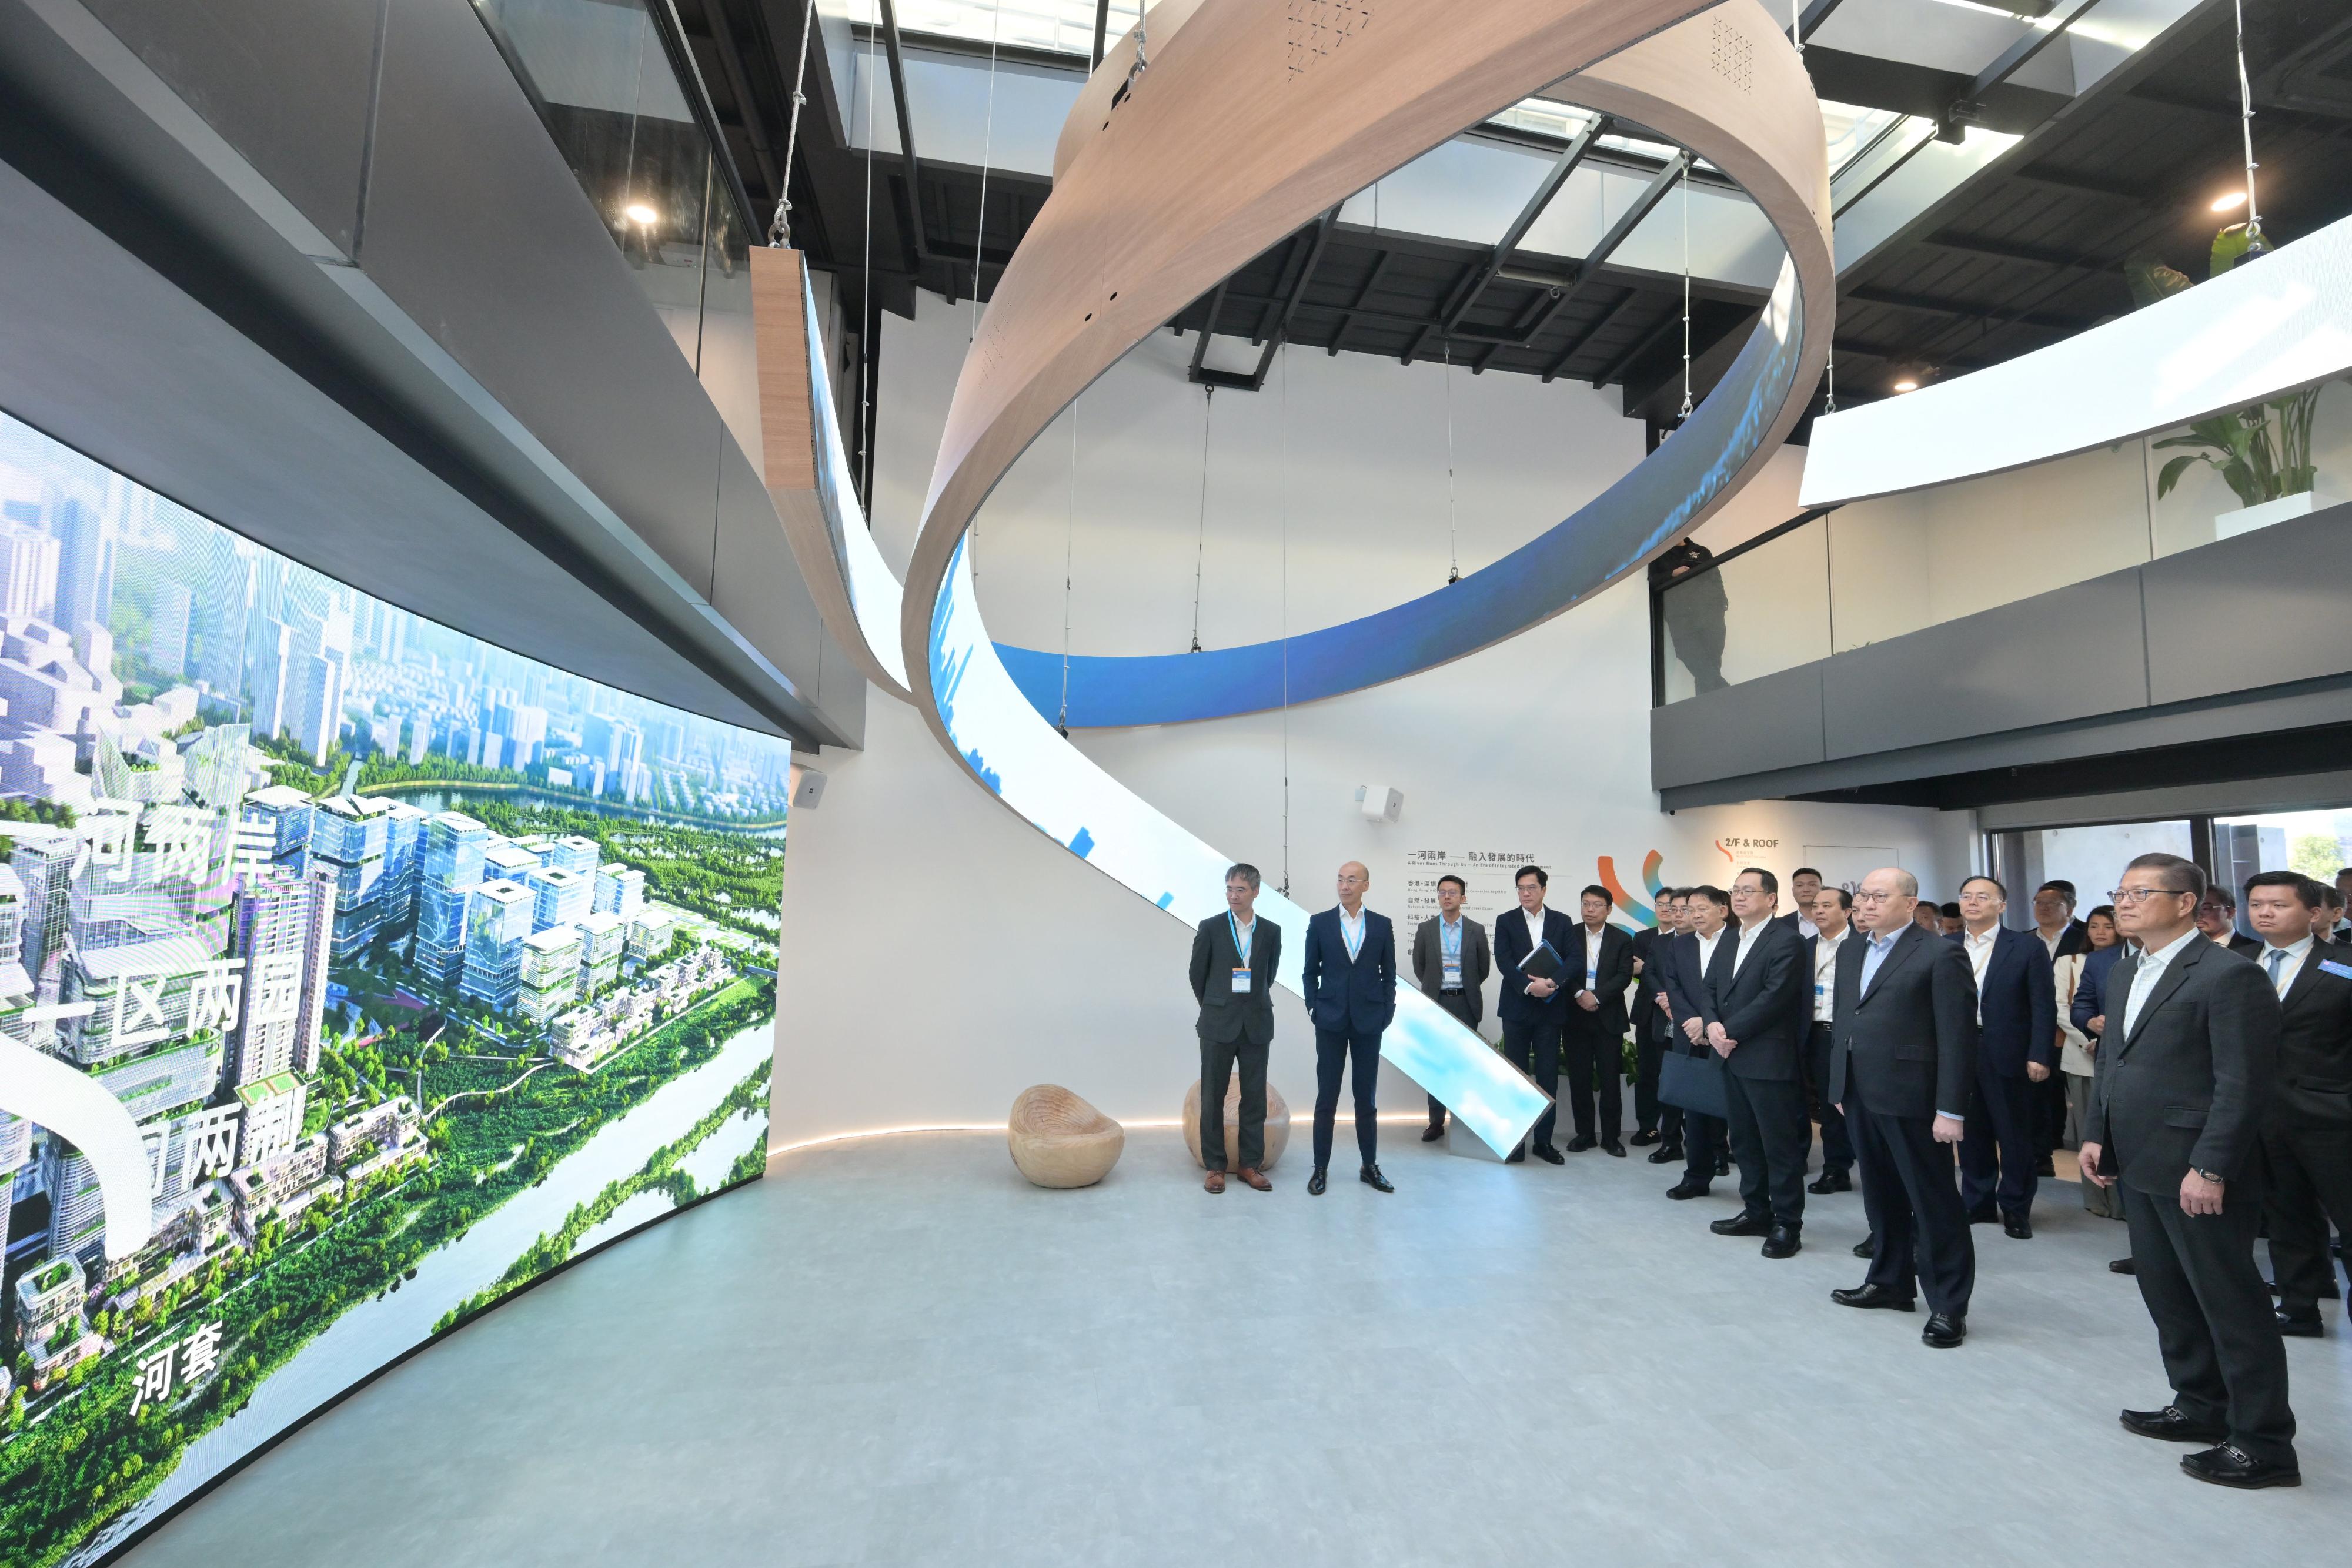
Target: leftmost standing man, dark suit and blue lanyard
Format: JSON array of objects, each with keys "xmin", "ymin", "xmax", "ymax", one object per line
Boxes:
[{"xmin": 1192, "ymin": 865, "xmax": 1282, "ymax": 1192}]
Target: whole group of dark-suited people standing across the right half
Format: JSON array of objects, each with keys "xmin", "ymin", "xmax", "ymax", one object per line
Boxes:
[{"xmin": 1192, "ymin": 853, "xmax": 2324, "ymax": 1488}]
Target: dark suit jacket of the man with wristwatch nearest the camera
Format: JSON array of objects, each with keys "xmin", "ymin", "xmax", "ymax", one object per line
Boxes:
[{"xmin": 2084, "ymin": 935, "xmax": 2279, "ymax": 1196}]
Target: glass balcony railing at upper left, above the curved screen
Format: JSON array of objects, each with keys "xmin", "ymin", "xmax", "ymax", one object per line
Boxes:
[{"xmin": 473, "ymin": 0, "xmax": 764, "ymax": 456}]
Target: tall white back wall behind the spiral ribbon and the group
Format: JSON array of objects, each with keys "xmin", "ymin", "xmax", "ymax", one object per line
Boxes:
[{"xmin": 774, "ymin": 296, "xmax": 1969, "ymax": 1145}]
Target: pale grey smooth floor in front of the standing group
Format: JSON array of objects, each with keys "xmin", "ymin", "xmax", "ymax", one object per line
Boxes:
[{"xmin": 127, "ymin": 1126, "xmax": 2352, "ymax": 1568}]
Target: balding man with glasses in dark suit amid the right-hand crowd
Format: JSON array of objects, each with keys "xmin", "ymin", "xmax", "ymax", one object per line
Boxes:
[{"xmin": 1830, "ymin": 865, "xmax": 1976, "ymax": 1349}]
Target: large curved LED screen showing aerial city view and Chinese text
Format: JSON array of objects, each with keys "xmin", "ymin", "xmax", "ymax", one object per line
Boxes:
[{"xmin": 0, "ymin": 416, "xmax": 790, "ymax": 1568}]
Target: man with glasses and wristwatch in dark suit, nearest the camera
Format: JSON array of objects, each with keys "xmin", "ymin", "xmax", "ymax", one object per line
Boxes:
[{"xmin": 2082, "ymin": 853, "xmax": 2303, "ymax": 1488}]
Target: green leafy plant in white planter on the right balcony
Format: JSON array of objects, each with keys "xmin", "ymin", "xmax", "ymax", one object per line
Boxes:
[{"xmin": 2124, "ymin": 223, "xmax": 2338, "ymax": 539}]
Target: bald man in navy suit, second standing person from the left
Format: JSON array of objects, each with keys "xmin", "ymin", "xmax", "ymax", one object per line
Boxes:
[{"xmin": 1298, "ymin": 860, "xmax": 1397, "ymax": 1196}]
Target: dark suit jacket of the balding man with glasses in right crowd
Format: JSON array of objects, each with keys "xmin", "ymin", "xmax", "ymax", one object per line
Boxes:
[{"xmin": 1828, "ymin": 924, "xmax": 1976, "ymax": 1121}]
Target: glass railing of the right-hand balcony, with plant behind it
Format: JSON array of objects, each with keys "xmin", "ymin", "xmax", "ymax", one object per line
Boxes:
[{"xmin": 1653, "ymin": 381, "xmax": 2352, "ymax": 703}]
